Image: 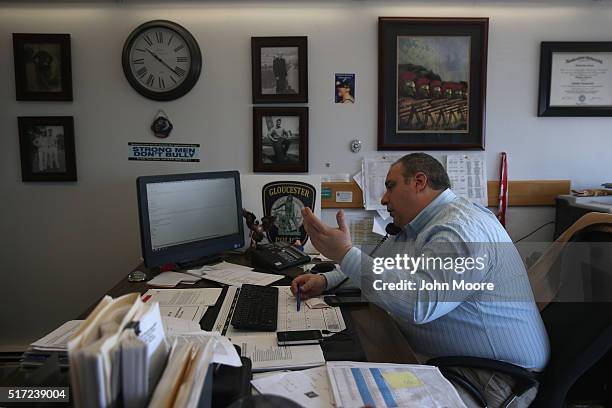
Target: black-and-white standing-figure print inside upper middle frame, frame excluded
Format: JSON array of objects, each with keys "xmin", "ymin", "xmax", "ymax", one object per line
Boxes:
[{"xmin": 261, "ymin": 47, "xmax": 300, "ymax": 95}]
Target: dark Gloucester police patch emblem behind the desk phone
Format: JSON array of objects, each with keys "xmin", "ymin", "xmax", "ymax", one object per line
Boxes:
[{"xmin": 261, "ymin": 181, "xmax": 317, "ymax": 245}]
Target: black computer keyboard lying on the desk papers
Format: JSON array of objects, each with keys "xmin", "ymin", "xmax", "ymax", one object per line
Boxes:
[{"xmin": 232, "ymin": 284, "xmax": 278, "ymax": 331}]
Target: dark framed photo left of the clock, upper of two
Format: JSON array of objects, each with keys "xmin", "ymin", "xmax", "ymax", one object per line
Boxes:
[{"xmin": 13, "ymin": 34, "xmax": 72, "ymax": 101}]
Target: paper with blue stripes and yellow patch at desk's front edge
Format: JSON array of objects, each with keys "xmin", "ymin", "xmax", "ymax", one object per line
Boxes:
[{"xmin": 327, "ymin": 361, "xmax": 465, "ymax": 408}]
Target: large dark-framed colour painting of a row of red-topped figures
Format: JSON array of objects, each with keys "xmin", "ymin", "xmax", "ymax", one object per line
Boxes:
[{"xmin": 378, "ymin": 17, "xmax": 489, "ymax": 150}]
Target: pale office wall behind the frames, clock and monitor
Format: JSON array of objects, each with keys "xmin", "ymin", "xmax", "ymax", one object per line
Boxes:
[{"xmin": 0, "ymin": 0, "xmax": 612, "ymax": 347}]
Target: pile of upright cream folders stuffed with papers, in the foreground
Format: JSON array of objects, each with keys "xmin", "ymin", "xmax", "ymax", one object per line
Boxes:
[{"xmin": 68, "ymin": 293, "xmax": 240, "ymax": 408}]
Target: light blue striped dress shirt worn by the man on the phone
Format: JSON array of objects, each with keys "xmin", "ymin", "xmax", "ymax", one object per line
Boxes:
[{"xmin": 325, "ymin": 189, "xmax": 550, "ymax": 371}]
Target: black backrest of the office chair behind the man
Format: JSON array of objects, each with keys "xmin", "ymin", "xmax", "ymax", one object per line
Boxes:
[{"xmin": 533, "ymin": 225, "xmax": 612, "ymax": 407}]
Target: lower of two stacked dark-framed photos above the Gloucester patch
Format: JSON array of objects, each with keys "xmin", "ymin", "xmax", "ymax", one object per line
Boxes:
[{"xmin": 253, "ymin": 108, "xmax": 308, "ymax": 173}]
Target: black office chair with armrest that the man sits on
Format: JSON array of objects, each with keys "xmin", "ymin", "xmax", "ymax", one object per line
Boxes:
[{"xmin": 427, "ymin": 217, "xmax": 612, "ymax": 408}]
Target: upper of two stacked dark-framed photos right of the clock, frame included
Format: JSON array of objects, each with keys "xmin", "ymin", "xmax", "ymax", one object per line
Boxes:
[{"xmin": 251, "ymin": 37, "xmax": 308, "ymax": 103}]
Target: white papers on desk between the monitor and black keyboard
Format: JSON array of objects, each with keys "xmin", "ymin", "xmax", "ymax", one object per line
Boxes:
[{"xmin": 187, "ymin": 262, "xmax": 284, "ymax": 286}]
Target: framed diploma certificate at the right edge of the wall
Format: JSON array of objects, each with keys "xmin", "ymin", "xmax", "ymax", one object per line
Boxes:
[{"xmin": 538, "ymin": 41, "xmax": 612, "ymax": 116}]
